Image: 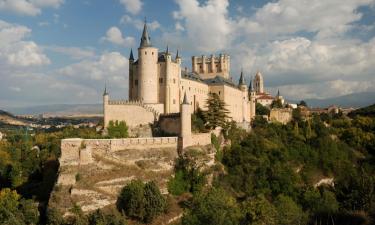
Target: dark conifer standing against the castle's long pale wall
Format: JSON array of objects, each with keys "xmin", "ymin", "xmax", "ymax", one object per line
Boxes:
[{"xmin": 204, "ymin": 93, "xmax": 229, "ymax": 129}]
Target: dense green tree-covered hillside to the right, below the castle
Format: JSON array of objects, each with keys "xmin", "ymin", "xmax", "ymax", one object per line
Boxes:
[{"xmin": 182, "ymin": 111, "xmax": 375, "ymax": 225}]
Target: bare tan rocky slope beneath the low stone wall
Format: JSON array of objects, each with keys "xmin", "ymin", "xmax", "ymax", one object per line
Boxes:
[{"xmin": 49, "ymin": 139, "xmax": 178, "ymax": 216}]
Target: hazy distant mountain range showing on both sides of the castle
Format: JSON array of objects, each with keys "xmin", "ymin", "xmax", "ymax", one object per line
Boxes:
[{"xmin": 5, "ymin": 92, "xmax": 375, "ymax": 116}]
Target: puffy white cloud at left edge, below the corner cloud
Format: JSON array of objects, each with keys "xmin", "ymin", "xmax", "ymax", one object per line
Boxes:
[{"xmin": 0, "ymin": 20, "xmax": 50, "ymax": 67}]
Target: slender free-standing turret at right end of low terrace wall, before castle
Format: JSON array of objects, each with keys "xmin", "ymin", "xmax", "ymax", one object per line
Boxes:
[{"xmin": 180, "ymin": 92, "xmax": 191, "ymax": 148}]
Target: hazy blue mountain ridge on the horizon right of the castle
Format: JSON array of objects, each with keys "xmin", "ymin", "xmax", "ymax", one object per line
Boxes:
[{"xmin": 291, "ymin": 92, "xmax": 375, "ymax": 108}]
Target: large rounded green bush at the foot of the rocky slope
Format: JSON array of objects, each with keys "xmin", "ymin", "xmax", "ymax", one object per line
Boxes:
[{"xmin": 116, "ymin": 180, "xmax": 166, "ymax": 223}]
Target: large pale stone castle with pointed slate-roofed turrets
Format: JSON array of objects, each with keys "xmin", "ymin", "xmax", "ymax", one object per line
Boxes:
[{"xmin": 103, "ymin": 23, "xmax": 273, "ymax": 137}]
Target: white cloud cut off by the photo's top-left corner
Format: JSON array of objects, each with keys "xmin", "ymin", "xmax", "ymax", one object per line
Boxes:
[{"xmin": 0, "ymin": 0, "xmax": 64, "ymax": 16}]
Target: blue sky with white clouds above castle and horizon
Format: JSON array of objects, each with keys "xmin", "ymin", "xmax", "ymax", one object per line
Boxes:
[{"xmin": 0, "ymin": 0, "xmax": 375, "ymax": 108}]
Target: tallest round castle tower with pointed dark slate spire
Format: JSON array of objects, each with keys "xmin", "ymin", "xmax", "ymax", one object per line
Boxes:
[{"xmin": 138, "ymin": 21, "xmax": 158, "ymax": 103}]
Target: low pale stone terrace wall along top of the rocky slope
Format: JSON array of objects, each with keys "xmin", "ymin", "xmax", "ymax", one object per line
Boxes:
[{"xmin": 60, "ymin": 137, "xmax": 178, "ymax": 166}]
